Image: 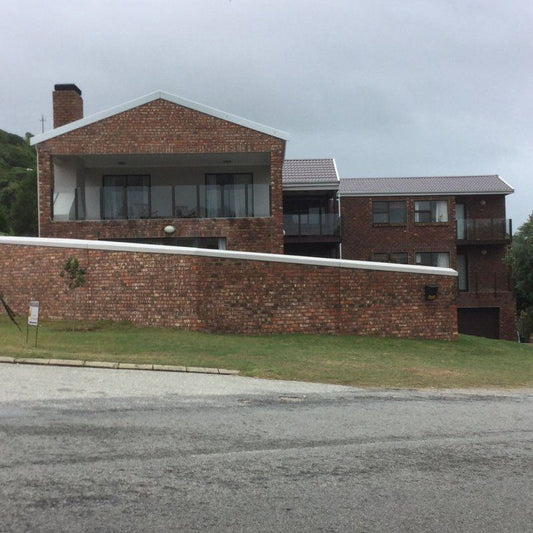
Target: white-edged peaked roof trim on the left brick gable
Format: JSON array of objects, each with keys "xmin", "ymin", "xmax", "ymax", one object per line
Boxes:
[{"xmin": 30, "ymin": 91, "xmax": 289, "ymax": 145}]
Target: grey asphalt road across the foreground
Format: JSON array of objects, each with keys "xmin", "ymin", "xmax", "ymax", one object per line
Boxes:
[{"xmin": 0, "ymin": 364, "xmax": 533, "ymax": 533}]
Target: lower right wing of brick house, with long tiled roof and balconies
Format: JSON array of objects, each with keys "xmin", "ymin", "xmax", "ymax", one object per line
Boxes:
[{"xmin": 339, "ymin": 176, "xmax": 516, "ymax": 340}]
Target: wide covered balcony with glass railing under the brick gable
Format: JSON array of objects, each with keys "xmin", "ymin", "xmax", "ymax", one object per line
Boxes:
[{"xmin": 53, "ymin": 153, "xmax": 271, "ymax": 221}]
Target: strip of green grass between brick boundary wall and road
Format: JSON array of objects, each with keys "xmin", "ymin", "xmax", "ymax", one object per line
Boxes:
[{"xmin": 0, "ymin": 316, "xmax": 533, "ymax": 388}]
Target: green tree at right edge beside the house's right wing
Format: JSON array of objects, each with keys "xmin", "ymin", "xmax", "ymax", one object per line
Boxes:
[{"xmin": 507, "ymin": 213, "xmax": 533, "ymax": 311}]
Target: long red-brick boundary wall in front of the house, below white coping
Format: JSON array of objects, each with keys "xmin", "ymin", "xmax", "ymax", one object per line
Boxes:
[{"xmin": 0, "ymin": 239, "xmax": 457, "ymax": 340}]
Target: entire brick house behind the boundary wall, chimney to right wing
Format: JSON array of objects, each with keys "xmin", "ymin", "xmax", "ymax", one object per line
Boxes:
[{"xmin": 32, "ymin": 84, "xmax": 515, "ymax": 339}]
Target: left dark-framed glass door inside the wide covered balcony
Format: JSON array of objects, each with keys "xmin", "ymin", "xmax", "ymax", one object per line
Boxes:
[{"xmin": 101, "ymin": 175, "xmax": 150, "ymax": 219}]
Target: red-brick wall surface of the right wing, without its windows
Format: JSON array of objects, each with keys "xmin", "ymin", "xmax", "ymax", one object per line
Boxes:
[{"xmin": 341, "ymin": 195, "xmax": 516, "ymax": 340}]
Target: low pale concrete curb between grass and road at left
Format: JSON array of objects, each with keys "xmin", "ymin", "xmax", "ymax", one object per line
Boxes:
[{"xmin": 0, "ymin": 356, "xmax": 240, "ymax": 376}]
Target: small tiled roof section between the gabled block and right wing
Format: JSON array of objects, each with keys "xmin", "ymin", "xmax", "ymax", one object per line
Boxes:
[{"xmin": 283, "ymin": 158, "xmax": 339, "ymax": 190}]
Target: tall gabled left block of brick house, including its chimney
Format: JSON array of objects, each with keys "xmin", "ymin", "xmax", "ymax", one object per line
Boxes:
[{"xmin": 32, "ymin": 84, "xmax": 287, "ymax": 253}]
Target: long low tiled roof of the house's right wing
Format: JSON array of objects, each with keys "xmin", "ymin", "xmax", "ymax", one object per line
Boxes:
[{"xmin": 339, "ymin": 174, "xmax": 514, "ymax": 196}]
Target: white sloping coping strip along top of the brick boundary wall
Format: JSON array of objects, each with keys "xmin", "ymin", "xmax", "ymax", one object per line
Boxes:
[{"xmin": 0, "ymin": 237, "xmax": 457, "ymax": 276}]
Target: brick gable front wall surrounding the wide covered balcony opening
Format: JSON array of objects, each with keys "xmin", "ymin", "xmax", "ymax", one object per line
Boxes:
[{"xmin": 38, "ymin": 99, "xmax": 285, "ymax": 253}]
